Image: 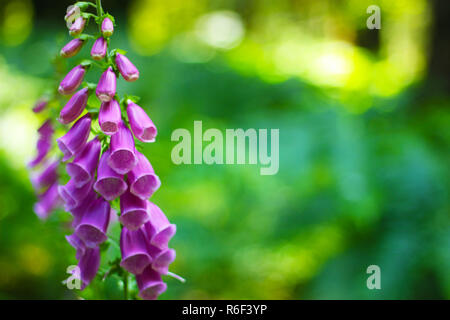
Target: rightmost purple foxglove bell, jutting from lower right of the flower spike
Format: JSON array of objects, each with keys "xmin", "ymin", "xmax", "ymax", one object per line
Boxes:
[{"xmin": 144, "ymin": 201, "xmax": 177, "ymax": 249}]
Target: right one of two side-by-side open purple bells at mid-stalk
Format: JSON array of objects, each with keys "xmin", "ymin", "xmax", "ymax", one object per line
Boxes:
[{"xmin": 128, "ymin": 151, "xmax": 161, "ymax": 200}]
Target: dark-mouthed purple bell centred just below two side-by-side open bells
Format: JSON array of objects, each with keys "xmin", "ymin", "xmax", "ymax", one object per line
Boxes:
[{"xmin": 119, "ymin": 191, "xmax": 150, "ymax": 230}]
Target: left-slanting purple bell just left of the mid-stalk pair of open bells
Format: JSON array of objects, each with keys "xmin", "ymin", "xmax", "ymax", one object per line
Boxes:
[{"xmin": 66, "ymin": 137, "xmax": 102, "ymax": 188}]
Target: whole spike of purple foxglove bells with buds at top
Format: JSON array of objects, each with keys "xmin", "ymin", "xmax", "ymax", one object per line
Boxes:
[{"xmin": 30, "ymin": 2, "xmax": 176, "ymax": 299}]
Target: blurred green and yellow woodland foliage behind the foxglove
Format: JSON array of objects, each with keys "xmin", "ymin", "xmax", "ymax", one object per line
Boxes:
[{"xmin": 0, "ymin": 0, "xmax": 450, "ymax": 299}]
